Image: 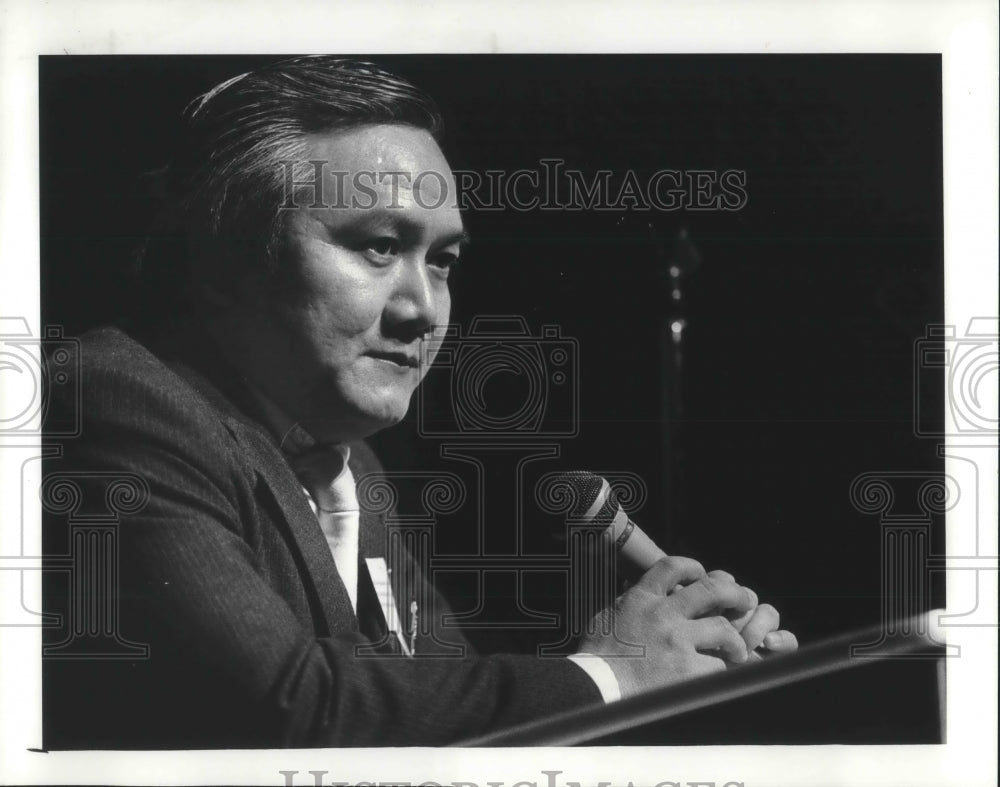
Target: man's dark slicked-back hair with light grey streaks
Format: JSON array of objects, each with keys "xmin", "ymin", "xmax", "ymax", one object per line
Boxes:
[{"xmin": 136, "ymin": 56, "xmax": 443, "ymax": 317}]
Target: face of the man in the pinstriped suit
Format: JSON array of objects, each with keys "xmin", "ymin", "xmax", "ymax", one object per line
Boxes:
[{"xmin": 221, "ymin": 125, "xmax": 464, "ymax": 442}]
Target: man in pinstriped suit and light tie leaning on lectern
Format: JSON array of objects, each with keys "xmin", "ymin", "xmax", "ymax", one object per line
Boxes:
[{"xmin": 43, "ymin": 57, "xmax": 796, "ymax": 748}]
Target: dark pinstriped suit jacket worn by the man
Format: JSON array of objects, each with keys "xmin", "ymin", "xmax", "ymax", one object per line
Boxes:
[{"xmin": 43, "ymin": 328, "xmax": 600, "ymax": 748}]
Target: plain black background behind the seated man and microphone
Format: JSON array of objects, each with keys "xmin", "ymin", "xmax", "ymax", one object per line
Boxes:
[{"xmin": 40, "ymin": 55, "xmax": 944, "ymax": 742}]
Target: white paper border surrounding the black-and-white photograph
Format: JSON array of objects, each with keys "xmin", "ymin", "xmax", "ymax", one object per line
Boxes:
[{"xmin": 0, "ymin": 0, "xmax": 998, "ymax": 787}]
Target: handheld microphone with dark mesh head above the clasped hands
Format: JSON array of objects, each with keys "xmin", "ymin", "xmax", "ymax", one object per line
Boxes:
[{"xmin": 559, "ymin": 470, "xmax": 667, "ymax": 579}]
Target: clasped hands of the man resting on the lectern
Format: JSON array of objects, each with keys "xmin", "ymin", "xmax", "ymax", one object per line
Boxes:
[{"xmin": 579, "ymin": 557, "xmax": 798, "ymax": 697}]
